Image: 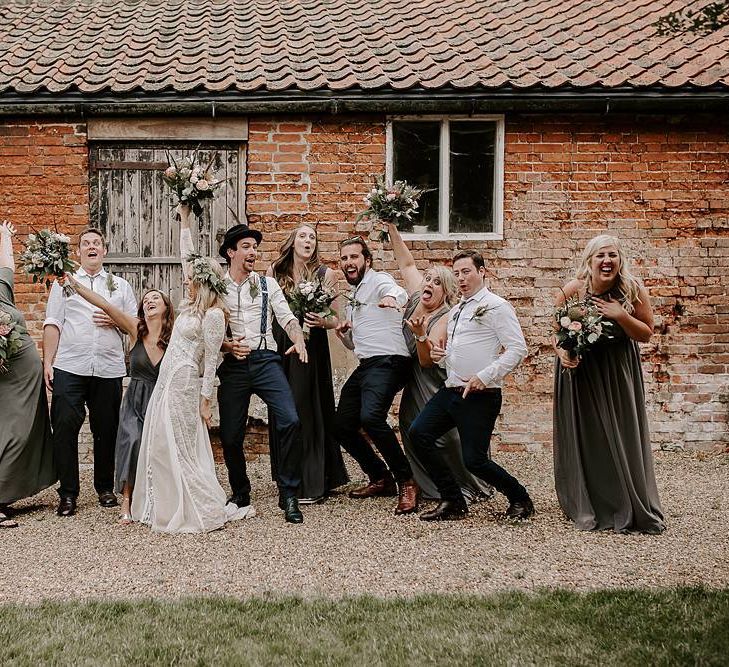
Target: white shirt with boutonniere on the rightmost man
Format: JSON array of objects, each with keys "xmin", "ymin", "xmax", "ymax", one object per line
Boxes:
[{"xmin": 445, "ymin": 287, "xmax": 527, "ymax": 388}]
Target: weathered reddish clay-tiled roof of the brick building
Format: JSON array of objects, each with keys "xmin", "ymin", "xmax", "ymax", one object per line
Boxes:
[{"xmin": 0, "ymin": 0, "xmax": 729, "ymax": 95}]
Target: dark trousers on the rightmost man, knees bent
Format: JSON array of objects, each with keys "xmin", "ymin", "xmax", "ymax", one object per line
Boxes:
[{"xmin": 409, "ymin": 387, "xmax": 529, "ymax": 502}]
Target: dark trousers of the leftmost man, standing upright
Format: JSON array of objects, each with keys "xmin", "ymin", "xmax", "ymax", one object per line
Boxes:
[{"xmin": 51, "ymin": 368, "xmax": 122, "ymax": 498}]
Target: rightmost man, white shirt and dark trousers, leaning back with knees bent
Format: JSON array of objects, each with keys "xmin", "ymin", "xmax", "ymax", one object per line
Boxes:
[{"xmin": 409, "ymin": 250, "xmax": 534, "ymax": 521}]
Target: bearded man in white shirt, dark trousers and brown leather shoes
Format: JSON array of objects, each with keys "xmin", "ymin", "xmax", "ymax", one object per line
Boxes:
[{"xmin": 334, "ymin": 236, "xmax": 418, "ymax": 514}]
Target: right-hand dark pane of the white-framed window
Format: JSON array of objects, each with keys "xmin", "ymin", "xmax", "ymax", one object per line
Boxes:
[{"xmin": 449, "ymin": 121, "xmax": 496, "ymax": 234}]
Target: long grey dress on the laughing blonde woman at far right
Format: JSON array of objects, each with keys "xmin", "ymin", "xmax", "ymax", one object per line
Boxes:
[{"xmin": 554, "ymin": 294, "xmax": 665, "ymax": 533}]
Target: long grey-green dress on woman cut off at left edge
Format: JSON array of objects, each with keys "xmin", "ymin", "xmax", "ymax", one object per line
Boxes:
[{"xmin": 0, "ymin": 268, "xmax": 58, "ymax": 505}]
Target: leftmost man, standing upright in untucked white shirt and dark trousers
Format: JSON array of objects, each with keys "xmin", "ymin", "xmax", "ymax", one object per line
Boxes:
[{"xmin": 43, "ymin": 228, "xmax": 137, "ymax": 516}]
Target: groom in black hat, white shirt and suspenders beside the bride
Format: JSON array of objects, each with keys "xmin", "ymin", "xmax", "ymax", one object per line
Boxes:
[{"xmin": 218, "ymin": 225, "xmax": 308, "ymax": 523}]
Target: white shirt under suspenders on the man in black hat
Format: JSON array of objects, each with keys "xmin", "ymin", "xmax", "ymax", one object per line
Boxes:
[{"xmin": 225, "ymin": 271, "xmax": 296, "ymax": 352}]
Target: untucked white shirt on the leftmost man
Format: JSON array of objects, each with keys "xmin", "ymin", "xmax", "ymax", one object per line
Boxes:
[{"xmin": 43, "ymin": 269, "xmax": 137, "ymax": 378}]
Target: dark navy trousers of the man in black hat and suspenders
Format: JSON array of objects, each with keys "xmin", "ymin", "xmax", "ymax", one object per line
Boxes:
[{"xmin": 218, "ymin": 350, "xmax": 301, "ymax": 504}]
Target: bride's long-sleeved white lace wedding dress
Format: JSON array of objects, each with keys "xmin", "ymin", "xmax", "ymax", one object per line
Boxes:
[{"xmin": 132, "ymin": 308, "xmax": 254, "ymax": 533}]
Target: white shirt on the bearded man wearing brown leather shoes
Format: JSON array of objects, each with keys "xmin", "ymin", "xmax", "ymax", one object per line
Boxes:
[{"xmin": 347, "ymin": 269, "xmax": 410, "ymax": 360}]
